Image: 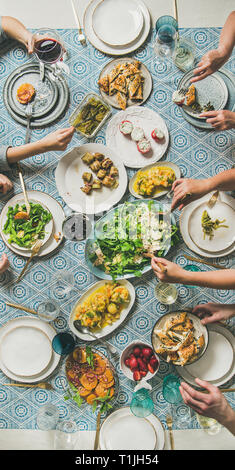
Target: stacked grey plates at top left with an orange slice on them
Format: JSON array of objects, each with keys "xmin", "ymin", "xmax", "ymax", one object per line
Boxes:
[{"xmin": 3, "ymin": 62, "xmax": 69, "ymax": 128}]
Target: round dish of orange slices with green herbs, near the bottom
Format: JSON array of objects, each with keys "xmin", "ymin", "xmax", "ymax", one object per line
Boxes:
[{"xmin": 65, "ymin": 346, "xmax": 117, "ymax": 413}]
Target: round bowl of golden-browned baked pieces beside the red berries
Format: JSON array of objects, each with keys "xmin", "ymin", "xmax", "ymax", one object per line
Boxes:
[{"xmin": 153, "ymin": 312, "xmax": 205, "ymax": 366}]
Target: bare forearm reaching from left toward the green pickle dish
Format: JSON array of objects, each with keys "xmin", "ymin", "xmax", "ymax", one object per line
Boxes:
[{"xmin": 6, "ymin": 127, "xmax": 75, "ymax": 165}]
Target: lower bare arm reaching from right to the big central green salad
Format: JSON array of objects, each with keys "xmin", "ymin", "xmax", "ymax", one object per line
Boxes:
[{"xmin": 151, "ymin": 257, "xmax": 235, "ymax": 289}]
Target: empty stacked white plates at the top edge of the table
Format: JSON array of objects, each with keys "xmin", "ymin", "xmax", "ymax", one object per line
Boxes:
[{"xmin": 83, "ymin": 0, "xmax": 150, "ymax": 56}]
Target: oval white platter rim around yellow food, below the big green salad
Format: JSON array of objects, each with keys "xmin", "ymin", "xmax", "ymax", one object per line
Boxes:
[{"xmin": 69, "ymin": 279, "xmax": 135, "ymax": 341}]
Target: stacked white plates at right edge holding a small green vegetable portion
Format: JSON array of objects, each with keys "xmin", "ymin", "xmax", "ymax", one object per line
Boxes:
[{"xmin": 180, "ymin": 193, "xmax": 235, "ymax": 258}]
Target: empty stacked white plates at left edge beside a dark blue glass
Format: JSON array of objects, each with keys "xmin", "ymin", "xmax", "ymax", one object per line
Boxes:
[{"xmin": 0, "ymin": 316, "xmax": 60, "ymax": 383}]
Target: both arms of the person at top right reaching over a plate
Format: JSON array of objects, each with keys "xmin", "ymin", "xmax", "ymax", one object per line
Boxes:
[{"xmin": 191, "ymin": 11, "xmax": 235, "ymax": 131}]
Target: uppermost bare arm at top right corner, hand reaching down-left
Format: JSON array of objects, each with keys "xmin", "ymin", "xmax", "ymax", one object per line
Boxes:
[{"xmin": 191, "ymin": 11, "xmax": 235, "ymax": 83}]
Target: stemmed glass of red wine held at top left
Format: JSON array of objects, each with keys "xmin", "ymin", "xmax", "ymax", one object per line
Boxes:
[{"xmin": 33, "ymin": 28, "xmax": 66, "ymax": 79}]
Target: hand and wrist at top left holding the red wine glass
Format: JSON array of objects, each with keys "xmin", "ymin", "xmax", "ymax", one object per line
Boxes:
[{"xmin": 2, "ymin": 16, "xmax": 33, "ymax": 54}]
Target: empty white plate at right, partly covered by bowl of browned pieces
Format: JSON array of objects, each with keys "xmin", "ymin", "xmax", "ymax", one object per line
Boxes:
[{"xmin": 182, "ymin": 331, "xmax": 233, "ymax": 382}]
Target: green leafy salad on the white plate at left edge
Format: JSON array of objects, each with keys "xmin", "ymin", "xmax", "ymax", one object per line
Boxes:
[{"xmin": 3, "ymin": 202, "xmax": 52, "ymax": 248}]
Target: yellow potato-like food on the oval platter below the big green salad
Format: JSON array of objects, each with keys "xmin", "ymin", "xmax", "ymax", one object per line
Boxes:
[{"xmin": 73, "ymin": 282, "xmax": 130, "ymax": 331}]
